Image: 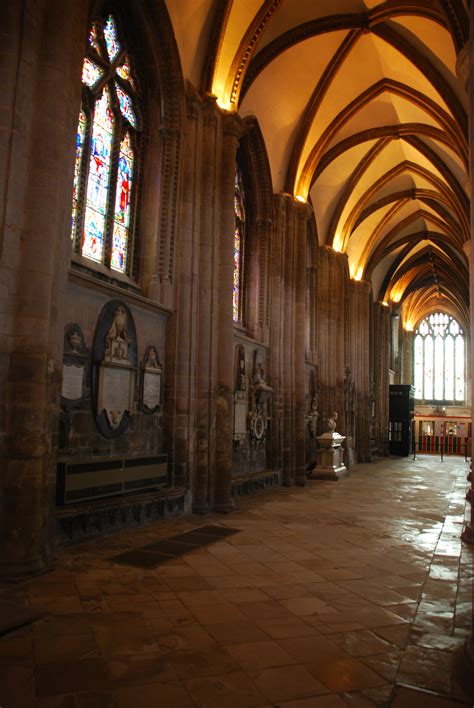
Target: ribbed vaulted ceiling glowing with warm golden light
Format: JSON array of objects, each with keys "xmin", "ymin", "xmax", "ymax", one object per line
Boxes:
[{"xmin": 168, "ymin": 0, "xmax": 470, "ymax": 328}]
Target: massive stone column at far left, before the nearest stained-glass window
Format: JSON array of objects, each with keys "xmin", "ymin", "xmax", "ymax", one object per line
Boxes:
[{"xmin": 0, "ymin": 0, "xmax": 87, "ymax": 578}]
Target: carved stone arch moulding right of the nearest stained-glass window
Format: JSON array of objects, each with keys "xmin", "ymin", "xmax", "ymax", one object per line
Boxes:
[{"xmin": 82, "ymin": 0, "xmax": 185, "ymax": 305}]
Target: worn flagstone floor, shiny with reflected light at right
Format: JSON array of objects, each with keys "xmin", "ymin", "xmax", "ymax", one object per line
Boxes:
[{"xmin": 0, "ymin": 456, "xmax": 473, "ymax": 708}]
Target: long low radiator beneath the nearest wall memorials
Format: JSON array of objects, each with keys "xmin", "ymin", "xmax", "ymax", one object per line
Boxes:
[{"xmin": 57, "ymin": 455, "xmax": 168, "ymax": 504}]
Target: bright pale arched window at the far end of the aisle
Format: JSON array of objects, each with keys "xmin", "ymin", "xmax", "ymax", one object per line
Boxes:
[{"xmin": 414, "ymin": 312, "xmax": 466, "ymax": 402}]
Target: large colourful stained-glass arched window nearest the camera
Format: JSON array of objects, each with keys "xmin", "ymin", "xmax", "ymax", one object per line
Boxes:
[{"xmin": 71, "ymin": 15, "xmax": 141, "ymax": 274}]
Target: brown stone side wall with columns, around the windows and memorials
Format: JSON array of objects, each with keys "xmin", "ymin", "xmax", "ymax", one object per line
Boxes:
[{"xmin": 0, "ymin": 0, "xmax": 396, "ymax": 576}]
